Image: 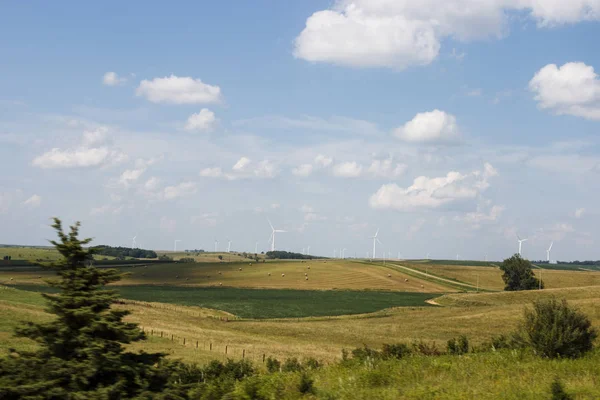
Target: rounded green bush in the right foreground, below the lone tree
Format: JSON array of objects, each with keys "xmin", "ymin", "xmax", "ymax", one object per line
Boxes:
[{"xmin": 516, "ymin": 298, "xmax": 598, "ymax": 358}]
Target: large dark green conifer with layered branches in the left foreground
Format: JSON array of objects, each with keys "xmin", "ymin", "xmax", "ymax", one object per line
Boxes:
[{"xmin": 0, "ymin": 218, "xmax": 168, "ymax": 399}]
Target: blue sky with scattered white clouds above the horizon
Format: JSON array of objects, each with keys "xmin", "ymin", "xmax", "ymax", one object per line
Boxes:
[{"xmin": 0, "ymin": 0, "xmax": 600, "ymax": 260}]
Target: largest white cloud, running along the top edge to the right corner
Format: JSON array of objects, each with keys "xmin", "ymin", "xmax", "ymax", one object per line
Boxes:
[{"xmin": 294, "ymin": 0, "xmax": 600, "ymax": 69}]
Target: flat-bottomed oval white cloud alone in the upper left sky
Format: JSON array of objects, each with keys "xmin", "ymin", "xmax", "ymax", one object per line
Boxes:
[{"xmin": 136, "ymin": 75, "xmax": 222, "ymax": 104}]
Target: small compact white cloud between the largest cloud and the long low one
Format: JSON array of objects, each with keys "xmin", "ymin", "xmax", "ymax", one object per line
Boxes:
[{"xmin": 394, "ymin": 110, "xmax": 459, "ymax": 143}]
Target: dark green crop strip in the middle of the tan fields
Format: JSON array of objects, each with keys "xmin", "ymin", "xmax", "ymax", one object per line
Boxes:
[{"xmin": 4, "ymin": 285, "xmax": 436, "ymax": 319}]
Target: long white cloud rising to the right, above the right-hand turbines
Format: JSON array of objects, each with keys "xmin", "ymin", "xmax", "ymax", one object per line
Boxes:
[{"xmin": 369, "ymin": 164, "xmax": 497, "ymax": 211}]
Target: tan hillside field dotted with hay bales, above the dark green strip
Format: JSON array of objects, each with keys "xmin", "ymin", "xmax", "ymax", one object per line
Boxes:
[{"xmin": 0, "ymin": 260, "xmax": 456, "ymax": 293}]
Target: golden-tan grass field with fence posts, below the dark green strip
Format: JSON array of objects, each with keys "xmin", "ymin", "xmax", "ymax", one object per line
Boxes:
[{"xmin": 0, "ymin": 287, "xmax": 600, "ymax": 363}]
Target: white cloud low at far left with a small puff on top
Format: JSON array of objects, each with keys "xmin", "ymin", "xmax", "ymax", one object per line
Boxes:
[{"xmin": 32, "ymin": 129, "xmax": 127, "ymax": 169}]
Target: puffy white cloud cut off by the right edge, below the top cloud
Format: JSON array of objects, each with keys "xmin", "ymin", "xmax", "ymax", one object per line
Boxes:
[{"xmin": 529, "ymin": 62, "xmax": 600, "ymax": 120}]
